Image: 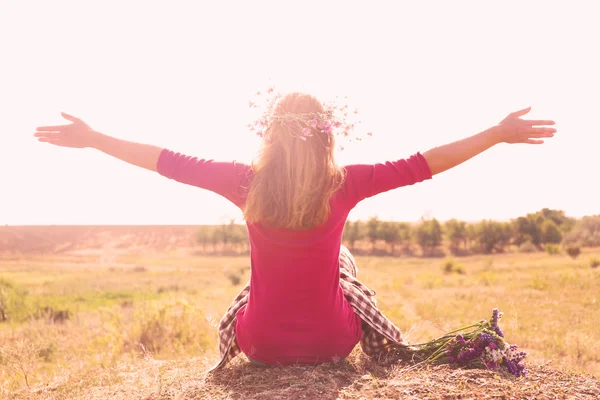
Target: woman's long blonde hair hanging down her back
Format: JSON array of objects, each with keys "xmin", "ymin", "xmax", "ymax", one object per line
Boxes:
[{"xmin": 244, "ymin": 93, "xmax": 345, "ymax": 230}]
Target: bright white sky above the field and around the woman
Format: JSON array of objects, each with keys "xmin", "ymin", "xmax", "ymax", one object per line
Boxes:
[{"xmin": 0, "ymin": 0, "xmax": 600, "ymax": 224}]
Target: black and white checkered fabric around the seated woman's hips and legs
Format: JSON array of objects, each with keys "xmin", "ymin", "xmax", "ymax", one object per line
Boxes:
[{"xmin": 209, "ymin": 246, "xmax": 408, "ymax": 372}]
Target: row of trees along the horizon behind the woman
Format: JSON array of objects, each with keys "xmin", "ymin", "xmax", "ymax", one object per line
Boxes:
[{"xmin": 196, "ymin": 208, "xmax": 600, "ymax": 255}]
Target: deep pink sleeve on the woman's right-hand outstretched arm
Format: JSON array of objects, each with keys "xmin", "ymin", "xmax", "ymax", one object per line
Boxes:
[{"xmin": 344, "ymin": 153, "xmax": 432, "ymax": 209}]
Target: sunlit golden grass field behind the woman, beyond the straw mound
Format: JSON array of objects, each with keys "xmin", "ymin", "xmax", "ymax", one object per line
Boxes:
[{"xmin": 0, "ymin": 239, "xmax": 600, "ymax": 398}]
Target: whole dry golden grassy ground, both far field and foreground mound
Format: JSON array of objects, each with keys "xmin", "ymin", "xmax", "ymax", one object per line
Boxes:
[{"xmin": 0, "ymin": 227, "xmax": 600, "ymax": 399}]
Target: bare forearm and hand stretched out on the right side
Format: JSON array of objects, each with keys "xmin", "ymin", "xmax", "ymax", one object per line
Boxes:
[{"xmin": 423, "ymin": 107, "xmax": 556, "ymax": 175}]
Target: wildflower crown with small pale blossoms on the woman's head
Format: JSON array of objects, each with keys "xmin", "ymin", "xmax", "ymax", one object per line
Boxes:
[{"xmin": 247, "ymin": 87, "xmax": 372, "ymax": 150}]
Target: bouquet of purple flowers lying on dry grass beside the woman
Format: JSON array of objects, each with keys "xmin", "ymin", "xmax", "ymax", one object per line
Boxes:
[{"xmin": 407, "ymin": 309, "xmax": 527, "ymax": 376}]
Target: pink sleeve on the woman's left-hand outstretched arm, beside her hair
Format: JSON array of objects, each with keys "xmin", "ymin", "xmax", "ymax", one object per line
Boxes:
[{"xmin": 156, "ymin": 149, "xmax": 250, "ymax": 207}]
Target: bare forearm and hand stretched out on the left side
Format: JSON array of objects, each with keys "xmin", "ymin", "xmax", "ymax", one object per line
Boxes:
[{"xmin": 34, "ymin": 113, "xmax": 163, "ymax": 171}]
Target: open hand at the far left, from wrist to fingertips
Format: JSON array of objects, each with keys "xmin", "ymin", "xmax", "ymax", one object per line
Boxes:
[{"xmin": 33, "ymin": 113, "xmax": 98, "ymax": 149}]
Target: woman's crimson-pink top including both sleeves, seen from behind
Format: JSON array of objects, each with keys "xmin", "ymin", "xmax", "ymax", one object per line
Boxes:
[{"xmin": 157, "ymin": 149, "xmax": 431, "ymax": 365}]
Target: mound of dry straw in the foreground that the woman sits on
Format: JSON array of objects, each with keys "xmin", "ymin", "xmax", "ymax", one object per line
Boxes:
[{"xmin": 5, "ymin": 349, "xmax": 600, "ymax": 400}]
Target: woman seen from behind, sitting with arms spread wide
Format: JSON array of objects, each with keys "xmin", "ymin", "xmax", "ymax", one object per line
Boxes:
[{"xmin": 35, "ymin": 93, "xmax": 556, "ymax": 367}]
